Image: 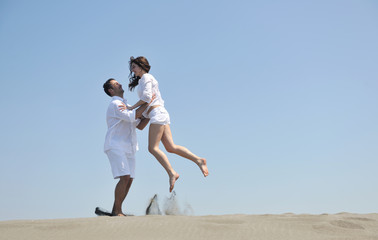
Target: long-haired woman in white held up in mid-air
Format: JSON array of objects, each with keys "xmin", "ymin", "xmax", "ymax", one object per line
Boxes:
[{"xmin": 129, "ymin": 57, "xmax": 209, "ymax": 192}]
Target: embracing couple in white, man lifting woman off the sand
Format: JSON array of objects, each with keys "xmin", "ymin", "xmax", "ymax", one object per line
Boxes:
[{"xmin": 103, "ymin": 57, "xmax": 209, "ymax": 216}]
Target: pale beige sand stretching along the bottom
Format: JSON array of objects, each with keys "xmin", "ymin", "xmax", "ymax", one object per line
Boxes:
[{"xmin": 0, "ymin": 213, "xmax": 378, "ymax": 240}]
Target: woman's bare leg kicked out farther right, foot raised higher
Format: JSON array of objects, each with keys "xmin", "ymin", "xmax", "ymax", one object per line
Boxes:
[{"xmin": 161, "ymin": 125, "xmax": 209, "ymax": 177}]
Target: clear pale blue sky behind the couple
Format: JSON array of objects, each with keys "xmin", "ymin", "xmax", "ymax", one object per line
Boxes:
[{"xmin": 0, "ymin": 0, "xmax": 378, "ymax": 220}]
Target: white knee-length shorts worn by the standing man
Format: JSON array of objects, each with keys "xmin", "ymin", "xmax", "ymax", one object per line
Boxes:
[{"xmin": 106, "ymin": 149, "xmax": 135, "ymax": 179}]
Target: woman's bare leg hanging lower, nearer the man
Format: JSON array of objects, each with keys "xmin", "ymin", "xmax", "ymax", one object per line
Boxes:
[{"xmin": 148, "ymin": 124, "xmax": 180, "ymax": 192}]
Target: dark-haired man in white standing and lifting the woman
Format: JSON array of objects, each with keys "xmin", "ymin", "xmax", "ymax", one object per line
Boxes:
[{"xmin": 103, "ymin": 78, "xmax": 149, "ymax": 216}]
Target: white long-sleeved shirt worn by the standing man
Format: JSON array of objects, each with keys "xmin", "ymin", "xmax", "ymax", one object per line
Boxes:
[{"xmin": 104, "ymin": 96, "xmax": 140, "ymax": 153}]
